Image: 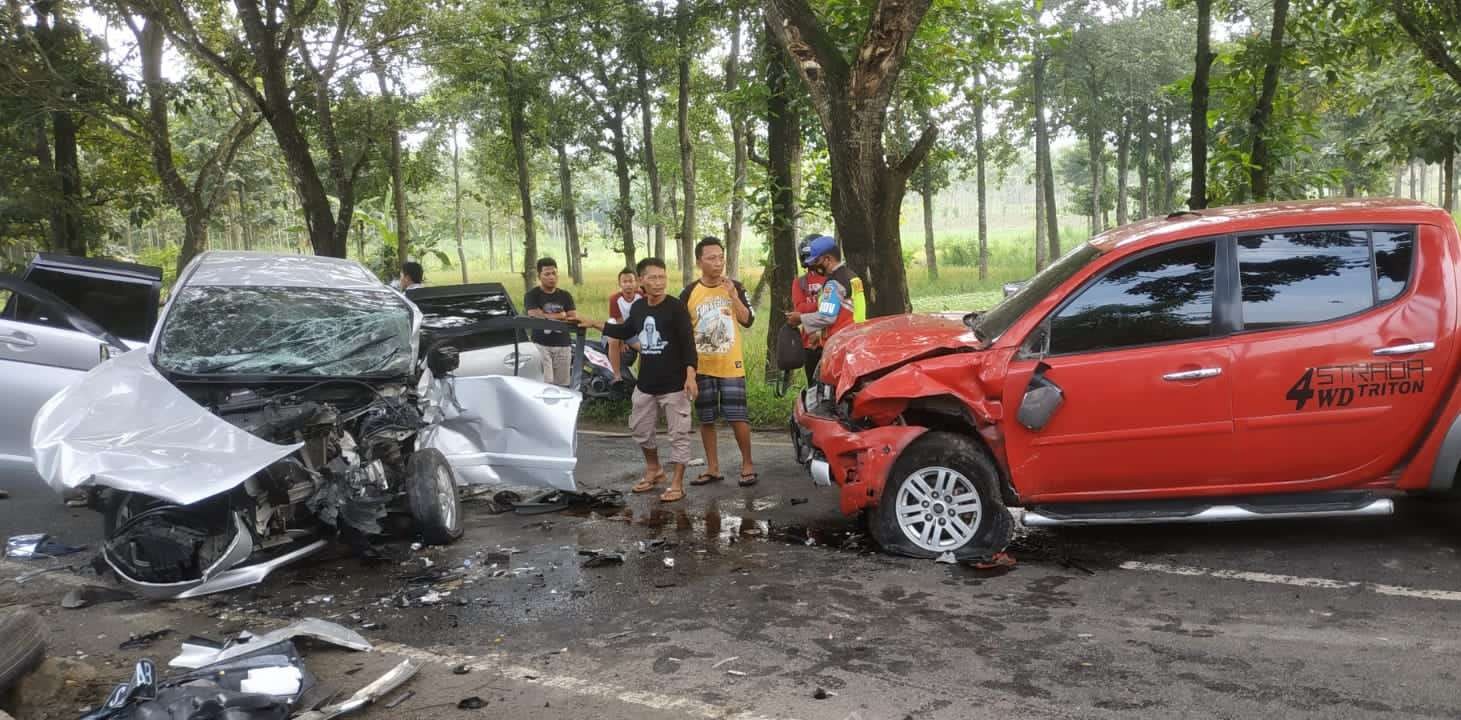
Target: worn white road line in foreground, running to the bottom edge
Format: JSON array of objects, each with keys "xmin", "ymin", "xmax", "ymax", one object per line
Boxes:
[{"xmin": 375, "ymin": 643, "xmax": 773, "ymax": 720}]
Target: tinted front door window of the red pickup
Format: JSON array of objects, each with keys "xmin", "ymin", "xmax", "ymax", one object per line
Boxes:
[{"xmin": 1050, "ymin": 241, "xmax": 1214, "ymax": 353}]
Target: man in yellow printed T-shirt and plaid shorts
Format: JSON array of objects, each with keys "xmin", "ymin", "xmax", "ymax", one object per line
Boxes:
[{"xmin": 679, "ymin": 237, "xmax": 757, "ymax": 488}]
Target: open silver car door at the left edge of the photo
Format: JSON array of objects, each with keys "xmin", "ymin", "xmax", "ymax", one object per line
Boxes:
[{"xmin": 0, "ymin": 276, "xmax": 126, "ymax": 466}]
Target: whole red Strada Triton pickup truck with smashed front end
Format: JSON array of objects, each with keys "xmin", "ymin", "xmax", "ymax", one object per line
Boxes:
[{"xmin": 792, "ymin": 200, "xmax": 1461, "ymax": 558}]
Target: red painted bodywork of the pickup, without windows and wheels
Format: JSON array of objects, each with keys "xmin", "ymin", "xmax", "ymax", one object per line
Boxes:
[{"xmin": 795, "ymin": 200, "xmax": 1461, "ymax": 513}]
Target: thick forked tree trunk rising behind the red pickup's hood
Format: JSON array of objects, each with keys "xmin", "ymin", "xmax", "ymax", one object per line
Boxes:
[{"xmin": 766, "ymin": 0, "xmax": 938, "ymax": 317}]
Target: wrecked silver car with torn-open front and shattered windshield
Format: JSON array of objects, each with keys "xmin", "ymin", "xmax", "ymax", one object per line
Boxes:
[{"xmin": 31, "ymin": 253, "xmax": 583, "ymax": 597}]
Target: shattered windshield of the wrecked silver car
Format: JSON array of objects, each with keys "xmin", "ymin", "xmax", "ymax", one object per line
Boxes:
[{"xmin": 156, "ymin": 286, "xmax": 411, "ymax": 377}]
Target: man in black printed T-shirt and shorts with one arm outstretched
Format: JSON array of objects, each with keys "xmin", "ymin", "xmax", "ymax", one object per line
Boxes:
[{"xmin": 579, "ymin": 257, "xmax": 698, "ymax": 502}]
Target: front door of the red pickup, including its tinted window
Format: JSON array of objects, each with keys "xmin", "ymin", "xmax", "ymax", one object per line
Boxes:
[{"xmin": 1005, "ymin": 240, "xmax": 1233, "ymax": 502}]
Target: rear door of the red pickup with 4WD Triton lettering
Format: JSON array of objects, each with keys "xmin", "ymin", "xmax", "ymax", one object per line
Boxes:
[{"xmin": 1233, "ymin": 226, "xmax": 1457, "ymax": 491}]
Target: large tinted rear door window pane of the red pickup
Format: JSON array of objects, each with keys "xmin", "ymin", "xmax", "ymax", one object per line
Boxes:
[{"xmin": 1237, "ymin": 229, "xmax": 1373, "ymax": 330}]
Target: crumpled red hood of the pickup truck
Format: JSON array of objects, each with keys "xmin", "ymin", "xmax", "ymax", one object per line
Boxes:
[{"xmin": 821, "ymin": 315, "xmax": 977, "ymax": 399}]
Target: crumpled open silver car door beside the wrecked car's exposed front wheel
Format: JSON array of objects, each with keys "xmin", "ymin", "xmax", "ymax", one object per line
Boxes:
[{"xmin": 421, "ymin": 317, "xmax": 584, "ymax": 491}]
